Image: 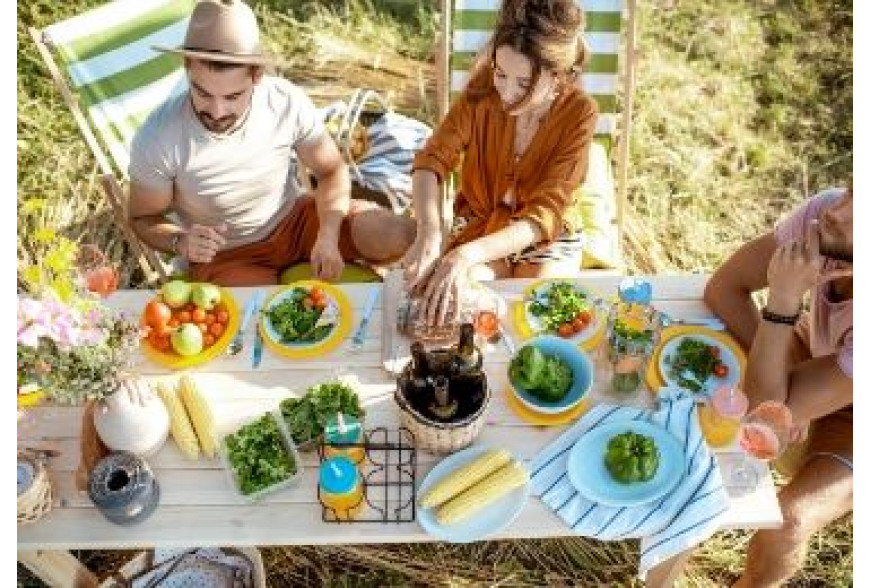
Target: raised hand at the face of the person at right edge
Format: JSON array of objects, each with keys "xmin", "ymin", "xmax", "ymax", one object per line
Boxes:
[{"xmin": 767, "ymin": 222, "xmax": 824, "ymax": 316}]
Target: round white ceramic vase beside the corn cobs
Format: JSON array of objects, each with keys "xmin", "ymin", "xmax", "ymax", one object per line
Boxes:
[{"xmin": 94, "ymin": 383, "xmax": 169, "ymax": 457}]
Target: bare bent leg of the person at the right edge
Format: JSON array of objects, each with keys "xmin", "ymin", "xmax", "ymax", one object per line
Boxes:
[{"xmin": 734, "ymin": 456, "xmax": 853, "ymax": 588}]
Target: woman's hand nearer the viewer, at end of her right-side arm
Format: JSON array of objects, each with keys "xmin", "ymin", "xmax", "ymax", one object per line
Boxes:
[{"xmin": 420, "ymin": 247, "xmax": 475, "ymax": 326}]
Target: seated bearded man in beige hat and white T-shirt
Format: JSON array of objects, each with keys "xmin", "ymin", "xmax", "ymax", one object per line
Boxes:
[{"xmin": 129, "ymin": 0, "xmax": 415, "ymax": 286}]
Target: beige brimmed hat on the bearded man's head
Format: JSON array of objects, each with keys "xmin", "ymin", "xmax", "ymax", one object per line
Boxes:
[{"xmin": 153, "ymin": 0, "xmax": 274, "ymax": 65}]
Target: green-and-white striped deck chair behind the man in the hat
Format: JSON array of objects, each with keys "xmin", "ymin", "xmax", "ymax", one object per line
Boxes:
[{"xmin": 30, "ymin": 0, "xmax": 194, "ymax": 281}]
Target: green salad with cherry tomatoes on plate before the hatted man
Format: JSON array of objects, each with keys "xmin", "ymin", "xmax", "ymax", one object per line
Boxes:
[{"xmin": 266, "ymin": 287, "xmax": 335, "ymax": 343}]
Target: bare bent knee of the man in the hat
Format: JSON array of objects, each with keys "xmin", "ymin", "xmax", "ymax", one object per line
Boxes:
[{"xmin": 350, "ymin": 207, "xmax": 417, "ymax": 264}]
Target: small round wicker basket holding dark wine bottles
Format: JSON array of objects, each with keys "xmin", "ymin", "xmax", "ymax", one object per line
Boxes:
[{"xmin": 394, "ymin": 374, "xmax": 492, "ymax": 453}]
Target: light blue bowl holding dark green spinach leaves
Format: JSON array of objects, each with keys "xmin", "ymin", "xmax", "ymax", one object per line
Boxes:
[{"xmin": 508, "ymin": 335, "xmax": 594, "ymax": 414}]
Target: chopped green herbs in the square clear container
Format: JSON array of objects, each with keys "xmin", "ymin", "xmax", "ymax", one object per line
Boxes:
[{"xmin": 224, "ymin": 413, "xmax": 297, "ymax": 496}]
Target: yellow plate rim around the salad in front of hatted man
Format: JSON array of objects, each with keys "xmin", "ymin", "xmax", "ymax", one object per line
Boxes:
[{"xmin": 258, "ymin": 280, "xmax": 353, "ymax": 359}]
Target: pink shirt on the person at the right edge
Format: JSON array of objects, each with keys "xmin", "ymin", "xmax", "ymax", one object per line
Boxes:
[{"xmin": 775, "ymin": 189, "xmax": 852, "ymax": 378}]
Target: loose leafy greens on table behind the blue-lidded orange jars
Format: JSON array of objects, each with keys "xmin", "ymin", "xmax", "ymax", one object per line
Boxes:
[{"xmin": 280, "ymin": 381, "xmax": 364, "ymax": 444}]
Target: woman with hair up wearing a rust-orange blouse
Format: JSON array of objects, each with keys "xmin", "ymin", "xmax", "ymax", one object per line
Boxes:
[{"xmin": 404, "ymin": 0, "xmax": 596, "ymax": 324}]
